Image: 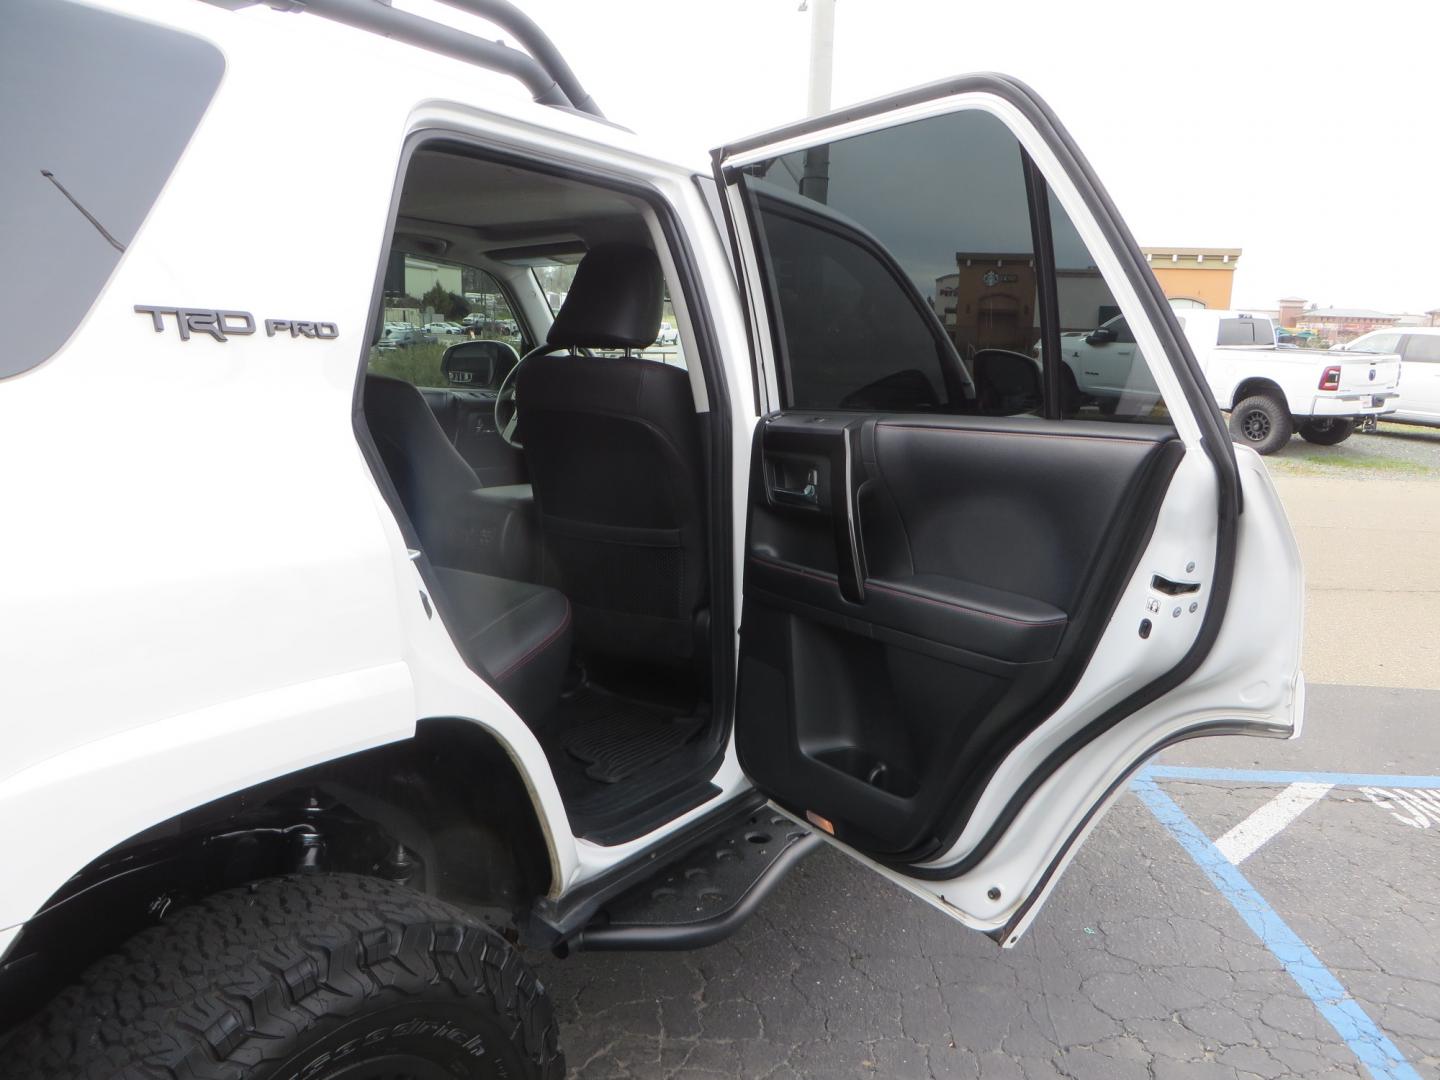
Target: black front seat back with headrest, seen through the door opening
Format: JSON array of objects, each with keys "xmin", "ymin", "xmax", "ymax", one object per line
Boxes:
[{"xmin": 516, "ymin": 243, "xmax": 707, "ymax": 661}]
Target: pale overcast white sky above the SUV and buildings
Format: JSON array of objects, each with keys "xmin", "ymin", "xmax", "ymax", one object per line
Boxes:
[{"xmin": 414, "ymin": 0, "xmax": 1440, "ymax": 311}]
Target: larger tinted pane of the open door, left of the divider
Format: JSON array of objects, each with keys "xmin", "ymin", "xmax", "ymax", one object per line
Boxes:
[{"xmin": 744, "ymin": 112, "xmax": 1037, "ymax": 409}]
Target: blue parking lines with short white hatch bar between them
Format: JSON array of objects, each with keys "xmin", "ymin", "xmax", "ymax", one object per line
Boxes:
[{"xmin": 1130, "ymin": 765, "xmax": 1422, "ymax": 1080}]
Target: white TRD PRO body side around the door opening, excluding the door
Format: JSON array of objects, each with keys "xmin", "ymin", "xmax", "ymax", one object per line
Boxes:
[{"xmin": 0, "ymin": 0, "xmax": 756, "ymax": 927}]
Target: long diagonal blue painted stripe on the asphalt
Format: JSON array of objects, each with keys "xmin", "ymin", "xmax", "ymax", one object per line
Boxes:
[{"xmin": 1130, "ymin": 766, "xmax": 1420, "ymax": 1080}]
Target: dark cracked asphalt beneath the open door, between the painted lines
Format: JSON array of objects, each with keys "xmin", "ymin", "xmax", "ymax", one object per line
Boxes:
[{"xmin": 533, "ymin": 687, "xmax": 1440, "ymax": 1080}]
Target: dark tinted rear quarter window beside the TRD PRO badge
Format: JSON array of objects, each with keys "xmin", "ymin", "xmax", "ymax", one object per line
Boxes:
[{"xmin": 0, "ymin": 0, "xmax": 225, "ymax": 379}]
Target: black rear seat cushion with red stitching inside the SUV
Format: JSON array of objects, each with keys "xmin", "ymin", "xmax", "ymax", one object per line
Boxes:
[{"xmin": 435, "ymin": 567, "xmax": 570, "ymax": 720}]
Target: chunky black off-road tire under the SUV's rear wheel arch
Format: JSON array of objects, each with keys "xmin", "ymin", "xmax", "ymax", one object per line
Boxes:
[{"xmin": 0, "ymin": 874, "xmax": 564, "ymax": 1080}]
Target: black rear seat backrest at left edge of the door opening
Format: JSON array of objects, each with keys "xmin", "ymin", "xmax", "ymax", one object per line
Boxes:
[{"xmin": 364, "ymin": 374, "xmax": 481, "ymax": 557}]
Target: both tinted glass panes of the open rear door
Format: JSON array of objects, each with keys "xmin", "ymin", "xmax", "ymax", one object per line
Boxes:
[{"xmin": 742, "ymin": 111, "xmax": 1168, "ymax": 420}]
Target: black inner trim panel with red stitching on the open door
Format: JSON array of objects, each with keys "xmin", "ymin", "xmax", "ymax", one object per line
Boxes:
[{"xmin": 737, "ymin": 413, "xmax": 1182, "ymax": 858}]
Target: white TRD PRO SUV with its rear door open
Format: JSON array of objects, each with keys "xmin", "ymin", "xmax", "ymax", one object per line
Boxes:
[{"xmin": 0, "ymin": 0, "xmax": 1307, "ymax": 1080}]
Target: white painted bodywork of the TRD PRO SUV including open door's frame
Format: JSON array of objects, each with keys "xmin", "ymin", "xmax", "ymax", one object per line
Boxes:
[{"xmin": 0, "ymin": 0, "xmax": 1300, "ymax": 952}]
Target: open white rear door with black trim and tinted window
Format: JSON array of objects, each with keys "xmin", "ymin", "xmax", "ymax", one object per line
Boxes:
[{"xmin": 714, "ymin": 75, "xmax": 1303, "ymax": 945}]
